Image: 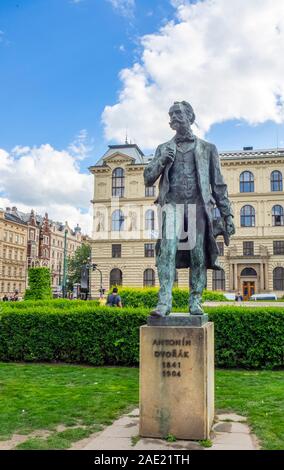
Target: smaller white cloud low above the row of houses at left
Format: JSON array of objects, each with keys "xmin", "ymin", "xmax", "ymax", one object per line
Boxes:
[{"xmin": 0, "ymin": 144, "xmax": 93, "ymax": 233}]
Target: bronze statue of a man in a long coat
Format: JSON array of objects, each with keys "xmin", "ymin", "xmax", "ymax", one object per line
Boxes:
[{"xmin": 144, "ymin": 101, "xmax": 235, "ymax": 317}]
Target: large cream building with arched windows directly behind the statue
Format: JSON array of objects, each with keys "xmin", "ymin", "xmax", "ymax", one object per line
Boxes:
[{"xmin": 90, "ymin": 144, "xmax": 284, "ymax": 298}]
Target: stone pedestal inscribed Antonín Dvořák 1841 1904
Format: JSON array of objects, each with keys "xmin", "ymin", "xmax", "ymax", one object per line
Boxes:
[{"xmin": 140, "ymin": 316, "xmax": 214, "ymax": 440}]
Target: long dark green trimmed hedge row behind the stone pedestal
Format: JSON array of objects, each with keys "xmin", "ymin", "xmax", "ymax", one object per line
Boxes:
[{"xmin": 0, "ymin": 305, "xmax": 284, "ymax": 369}]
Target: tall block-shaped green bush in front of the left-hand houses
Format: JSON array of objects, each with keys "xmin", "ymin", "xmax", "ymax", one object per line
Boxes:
[{"xmin": 25, "ymin": 268, "xmax": 52, "ymax": 300}]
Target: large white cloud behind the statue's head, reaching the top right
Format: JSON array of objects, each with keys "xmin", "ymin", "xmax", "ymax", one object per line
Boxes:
[{"xmin": 103, "ymin": 0, "xmax": 284, "ymax": 149}]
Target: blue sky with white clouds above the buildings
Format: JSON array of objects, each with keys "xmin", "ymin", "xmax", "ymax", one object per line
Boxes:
[{"xmin": 0, "ymin": 0, "xmax": 284, "ymax": 233}]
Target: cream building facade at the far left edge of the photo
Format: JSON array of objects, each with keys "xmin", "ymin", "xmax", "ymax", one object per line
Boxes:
[{"xmin": 0, "ymin": 208, "xmax": 28, "ymax": 298}]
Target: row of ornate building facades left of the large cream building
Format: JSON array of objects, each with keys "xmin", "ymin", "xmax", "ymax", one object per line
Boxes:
[{"xmin": 0, "ymin": 207, "xmax": 84, "ymax": 297}]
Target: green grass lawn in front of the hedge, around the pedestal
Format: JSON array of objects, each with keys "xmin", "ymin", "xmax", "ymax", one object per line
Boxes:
[{"xmin": 0, "ymin": 363, "xmax": 284, "ymax": 449}]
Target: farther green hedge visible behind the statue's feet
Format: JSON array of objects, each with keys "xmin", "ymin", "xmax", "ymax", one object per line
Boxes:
[{"xmin": 115, "ymin": 287, "xmax": 227, "ymax": 310}]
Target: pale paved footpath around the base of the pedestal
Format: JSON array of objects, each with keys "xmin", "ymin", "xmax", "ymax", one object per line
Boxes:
[{"xmin": 76, "ymin": 409, "xmax": 259, "ymax": 450}]
